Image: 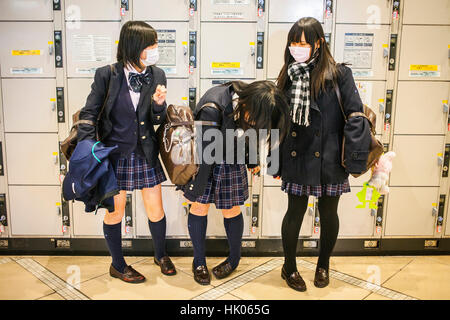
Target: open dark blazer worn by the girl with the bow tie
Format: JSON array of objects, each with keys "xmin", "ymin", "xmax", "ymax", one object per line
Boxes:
[{"xmin": 77, "ymin": 62, "xmax": 167, "ymax": 167}]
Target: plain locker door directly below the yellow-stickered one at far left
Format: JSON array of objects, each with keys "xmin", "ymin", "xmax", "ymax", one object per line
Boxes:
[{"xmin": 2, "ymin": 79, "xmax": 58, "ymax": 132}]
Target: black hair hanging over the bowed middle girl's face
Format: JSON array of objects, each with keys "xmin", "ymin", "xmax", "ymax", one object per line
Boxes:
[{"xmin": 231, "ymin": 80, "xmax": 290, "ymax": 142}]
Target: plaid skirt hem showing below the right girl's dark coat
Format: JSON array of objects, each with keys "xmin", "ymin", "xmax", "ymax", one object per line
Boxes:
[{"xmin": 281, "ymin": 179, "xmax": 351, "ymax": 198}]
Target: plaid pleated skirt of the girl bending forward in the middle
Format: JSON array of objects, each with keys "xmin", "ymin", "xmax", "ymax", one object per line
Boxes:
[{"xmin": 185, "ymin": 163, "xmax": 249, "ymax": 209}]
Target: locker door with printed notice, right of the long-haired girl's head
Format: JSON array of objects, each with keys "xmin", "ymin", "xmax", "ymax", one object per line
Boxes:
[{"xmin": 334, "ymin": 24, "xmax": 389, "ymax": 80}]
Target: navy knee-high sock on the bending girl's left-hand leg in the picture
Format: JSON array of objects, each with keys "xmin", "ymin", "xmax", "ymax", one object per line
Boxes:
[{"xmin": 188, "ymin": 213, "xmax": 208, "ymax": 268}]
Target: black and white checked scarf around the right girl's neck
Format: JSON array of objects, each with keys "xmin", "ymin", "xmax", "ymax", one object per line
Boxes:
[{"xmin": 288, "ymin": 51, "xmax": 317, "ymax": 127}]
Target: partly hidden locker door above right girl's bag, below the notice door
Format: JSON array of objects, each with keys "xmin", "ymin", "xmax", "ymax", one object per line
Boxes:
[{"xmin": 355, "ymin": 81, "xmax": 386, "ymax": 135}]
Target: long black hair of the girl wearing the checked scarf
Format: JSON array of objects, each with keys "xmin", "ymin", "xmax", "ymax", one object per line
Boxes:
[{"xmin": 277, "ymin": 17, "xmax": 338, "ymax": 98}]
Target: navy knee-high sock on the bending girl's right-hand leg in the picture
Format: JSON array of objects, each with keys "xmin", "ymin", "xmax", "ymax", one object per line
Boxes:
[{"xmin": 223, "ymin": 213, "xmax": 244, "ymax": 269}]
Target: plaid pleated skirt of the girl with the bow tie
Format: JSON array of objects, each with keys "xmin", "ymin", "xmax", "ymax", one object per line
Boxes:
[{"xmin": 115, "ymin": 153, "xmax": 167, "ymax": 191}]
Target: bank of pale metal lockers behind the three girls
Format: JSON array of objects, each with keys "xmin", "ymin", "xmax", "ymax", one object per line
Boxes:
[{"xmin": 0, "ymin": 0, "xmax": 450, "ymax": 295}]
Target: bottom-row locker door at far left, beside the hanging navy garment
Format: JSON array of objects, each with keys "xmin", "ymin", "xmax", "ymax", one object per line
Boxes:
[{"xmin": 9, "ymin": 186, "xmax": 62, "ymax": 236}]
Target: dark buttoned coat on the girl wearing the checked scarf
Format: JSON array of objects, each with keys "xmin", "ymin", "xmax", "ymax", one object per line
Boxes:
[{"xmin": 277, "ymin": 65, "xmax": 370, "ymax": 185}]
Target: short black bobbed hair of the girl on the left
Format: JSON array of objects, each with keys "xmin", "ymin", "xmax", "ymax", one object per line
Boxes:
[{"xmin": 117, "ymin": 21, "xmax": 158, "ymax": 68}]
